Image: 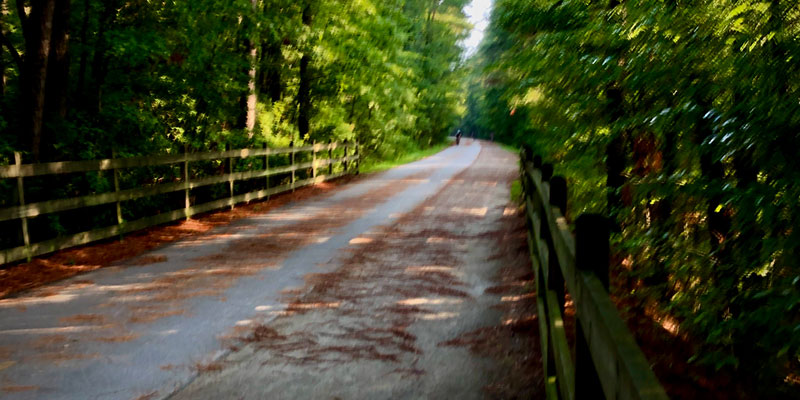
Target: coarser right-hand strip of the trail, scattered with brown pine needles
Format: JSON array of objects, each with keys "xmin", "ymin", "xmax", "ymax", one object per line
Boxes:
[{"xmin": 173, "ymin": 144, "xmax": 543, "ymax": 399}]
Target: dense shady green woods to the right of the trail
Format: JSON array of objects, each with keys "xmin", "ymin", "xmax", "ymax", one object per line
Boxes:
[{"xmin": 464, "ymin": 0, "xmax": 800, "ymax": 398}]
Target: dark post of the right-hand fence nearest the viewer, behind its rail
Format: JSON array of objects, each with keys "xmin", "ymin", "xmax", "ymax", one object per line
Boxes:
[{"xmin": 575, "ymin": 214, "xmax": 609, "ymax": 399}]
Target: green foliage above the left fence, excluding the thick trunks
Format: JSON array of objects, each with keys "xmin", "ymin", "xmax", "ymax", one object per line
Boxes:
[{"xmin": 0, "ymin": 0, "xmax": 469, "ymax": 159}]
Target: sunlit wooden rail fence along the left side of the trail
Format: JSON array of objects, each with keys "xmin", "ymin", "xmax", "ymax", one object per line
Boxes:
[{"xmin": 0, "ymin": 142, "xmax": 360, "ymax": 265}]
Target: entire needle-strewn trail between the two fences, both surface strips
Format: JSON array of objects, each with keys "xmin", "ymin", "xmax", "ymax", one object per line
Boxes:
[{"xmin": 0, "ymin": 142, "xmax": 541, "ymax": 399}]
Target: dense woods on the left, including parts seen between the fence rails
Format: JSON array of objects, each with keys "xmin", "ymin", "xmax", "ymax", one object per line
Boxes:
[{"xmin": 0, "ymin": 0, "xmax": 469, "ymax": 247}]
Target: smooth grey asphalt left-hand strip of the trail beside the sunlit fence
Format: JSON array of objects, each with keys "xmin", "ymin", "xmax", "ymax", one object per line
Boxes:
[{"xmin": 0, "ymin": 142, "xmax": 506, "ymax": 399}]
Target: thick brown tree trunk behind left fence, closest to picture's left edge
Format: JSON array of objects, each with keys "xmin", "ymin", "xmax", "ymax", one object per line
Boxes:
[{"xmin": 20, "ymin": 0, "xmax": 56, "ymax": 161}]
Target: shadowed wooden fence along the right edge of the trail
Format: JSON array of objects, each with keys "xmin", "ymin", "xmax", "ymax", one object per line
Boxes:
[{"xmin": 520, "ymin": 149, "xmax": 667, "ymax": 400}]
